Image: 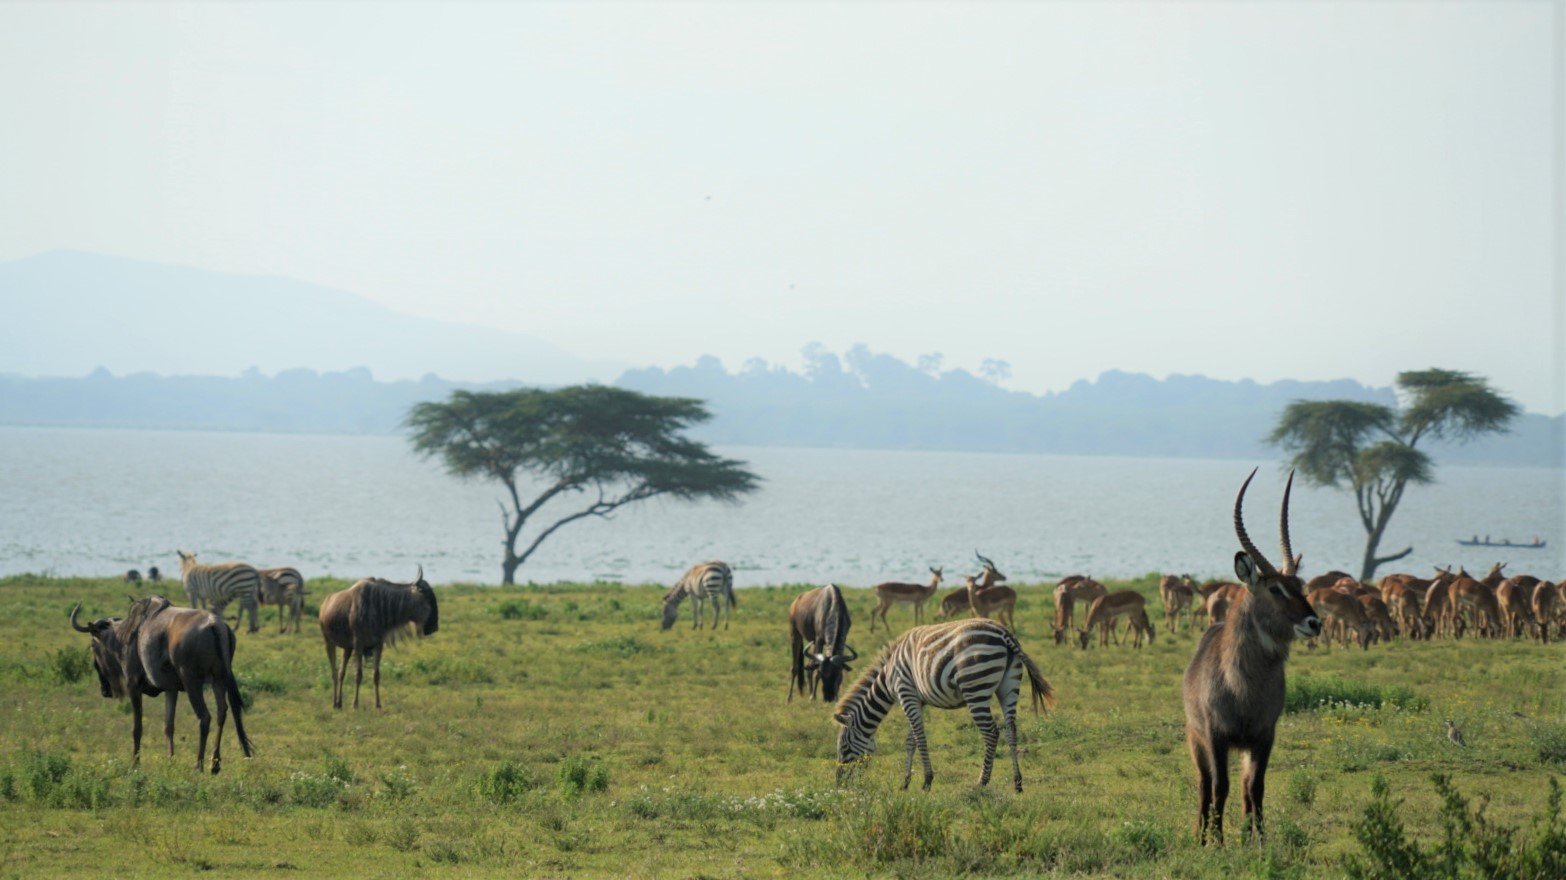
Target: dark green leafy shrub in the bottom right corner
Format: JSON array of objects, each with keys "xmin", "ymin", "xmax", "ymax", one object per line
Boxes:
[{"xmin": 1344, "ymin": 774, "xmax": 1566, "ymax": 880}]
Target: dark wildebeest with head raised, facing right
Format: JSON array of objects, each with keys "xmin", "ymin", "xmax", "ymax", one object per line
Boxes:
[{"xmin": 321, "ymin": 565, "xmax": 440, "ymax": 709}]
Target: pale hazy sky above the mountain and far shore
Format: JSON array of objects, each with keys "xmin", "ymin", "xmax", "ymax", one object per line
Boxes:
[{"xmin": 0, "ymin": 0, "xmax": 1566, "ymax": 413}]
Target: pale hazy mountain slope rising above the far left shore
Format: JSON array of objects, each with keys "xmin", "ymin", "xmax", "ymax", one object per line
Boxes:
[{"xmin": 0, "ymin": 251, "xmax": 628, "ymax": 384}]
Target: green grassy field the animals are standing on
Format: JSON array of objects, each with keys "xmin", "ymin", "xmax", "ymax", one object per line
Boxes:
[{"xmin": 0, "ymin": 576, "xmax": 1566, "ymax": 877}]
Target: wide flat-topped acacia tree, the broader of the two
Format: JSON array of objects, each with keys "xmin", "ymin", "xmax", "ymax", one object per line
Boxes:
[{"xmin": 404, "ymin": 385, "xmax": 761, "ymax": 584}]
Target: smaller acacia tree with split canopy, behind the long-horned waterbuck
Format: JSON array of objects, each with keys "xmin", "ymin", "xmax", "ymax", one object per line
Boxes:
[{"xmin": 1267, "ymin": 368, "xmax": 1517, "ymax": 581}]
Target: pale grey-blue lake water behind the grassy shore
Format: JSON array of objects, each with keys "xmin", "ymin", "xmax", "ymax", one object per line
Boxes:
[{"xmin": 0, "ymin": 427, "xmax": 1566, "ymax": 586}]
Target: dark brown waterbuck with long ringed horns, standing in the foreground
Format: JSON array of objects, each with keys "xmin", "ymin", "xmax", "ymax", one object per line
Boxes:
[{"xmin": 1182, "ymin": 470, "xmax": 1322, "ymax": 846}]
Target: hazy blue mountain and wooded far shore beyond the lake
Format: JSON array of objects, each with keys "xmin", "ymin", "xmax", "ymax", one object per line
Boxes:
[{"xmin": 0, "ymin": 252, "xmax": 1566, "ymax": 467}]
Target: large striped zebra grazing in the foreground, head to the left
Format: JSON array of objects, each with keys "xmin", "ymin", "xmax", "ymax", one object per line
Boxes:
[{"xmin": 832, "ymin": 619, "xmax": 1055, "ymax": 791}]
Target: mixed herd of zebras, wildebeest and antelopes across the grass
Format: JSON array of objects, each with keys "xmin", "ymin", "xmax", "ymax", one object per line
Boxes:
[{"xmin": 70, "ymin": 471, "xmax": 1566, "ymax": 844}]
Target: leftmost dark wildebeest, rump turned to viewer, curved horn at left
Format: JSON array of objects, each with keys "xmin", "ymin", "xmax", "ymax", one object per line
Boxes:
[{"xmin": 70, "ymin": 597, "xmax": 251, "ymax": 774}]
